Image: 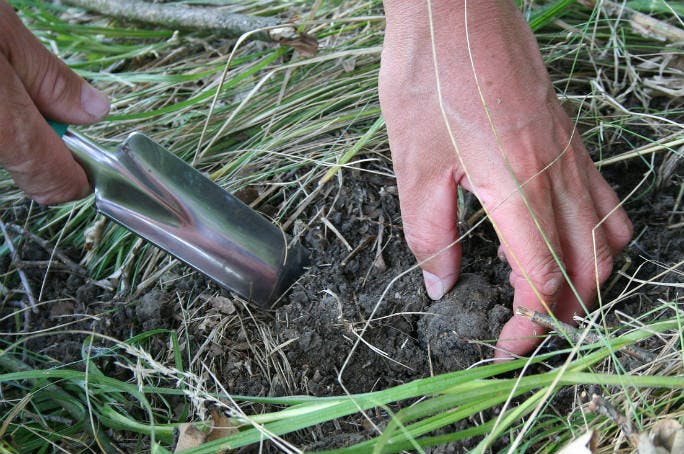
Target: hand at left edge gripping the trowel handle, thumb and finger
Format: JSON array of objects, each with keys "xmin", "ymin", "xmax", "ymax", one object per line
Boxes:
[{"xmin": 0, "ymin": 0, "xmax": 109, "ymax": 204}]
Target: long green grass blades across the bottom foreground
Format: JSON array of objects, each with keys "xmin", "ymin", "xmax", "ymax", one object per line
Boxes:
[{"xmin": 0, "ymin": 312, "xmax": 684, "ymax": 453}]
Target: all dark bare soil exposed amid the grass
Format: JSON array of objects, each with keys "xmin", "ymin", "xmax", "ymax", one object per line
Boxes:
[{"xmin": 0, "ymin": 139, "xmax": 684, "ymax": 452}]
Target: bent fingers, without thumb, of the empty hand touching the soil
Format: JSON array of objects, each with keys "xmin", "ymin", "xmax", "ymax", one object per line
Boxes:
[{"xmin": 493, "ymin": 148, "xmax": 631, "ymax": 358}]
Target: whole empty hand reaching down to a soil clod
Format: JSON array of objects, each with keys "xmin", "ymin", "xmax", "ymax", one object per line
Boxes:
[{"xmin": 379, "ymin": 0, "xmax": 632, "ymax": 357}]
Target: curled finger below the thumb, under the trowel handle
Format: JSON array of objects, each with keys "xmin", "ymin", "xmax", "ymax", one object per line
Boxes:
[{"xmin": 0, "ymin": 54, "xmax": 89, "ymax": 204}]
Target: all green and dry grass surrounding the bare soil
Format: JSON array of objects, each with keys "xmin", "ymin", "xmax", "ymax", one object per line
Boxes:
[{"xmin": 0, "ymin": 0, "xmax": 684, "ymax": 453}]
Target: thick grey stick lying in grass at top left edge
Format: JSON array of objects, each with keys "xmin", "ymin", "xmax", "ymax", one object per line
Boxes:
[{"xmin": 65, "ymin": 0, "xmax": 296, "ymax": 41}]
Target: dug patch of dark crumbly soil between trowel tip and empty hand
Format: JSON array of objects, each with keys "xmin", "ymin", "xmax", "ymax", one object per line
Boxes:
[{"xmin": 275, "ymin": 173, "xmax": 510, "ymax": 395}]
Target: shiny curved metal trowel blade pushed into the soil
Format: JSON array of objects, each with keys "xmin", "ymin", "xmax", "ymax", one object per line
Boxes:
[{"xmin": 62, "ymin": 131, "xmax": 307, "ymax": 307}]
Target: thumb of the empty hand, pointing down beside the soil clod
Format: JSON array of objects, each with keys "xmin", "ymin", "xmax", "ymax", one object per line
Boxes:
[{"xmin": 397, "ymin": 170, "xmax": 461, "ymax": 300}]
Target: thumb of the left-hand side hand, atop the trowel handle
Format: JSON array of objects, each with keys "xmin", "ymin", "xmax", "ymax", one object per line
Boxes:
[{"xmin": 0, "ymin": 2, "xmax": 109, "ymax": 124}]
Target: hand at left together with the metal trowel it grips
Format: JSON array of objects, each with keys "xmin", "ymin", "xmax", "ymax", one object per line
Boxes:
[{"xmin": 0, "ymin": 0, "xmax": 305, "ymax": 306}]
